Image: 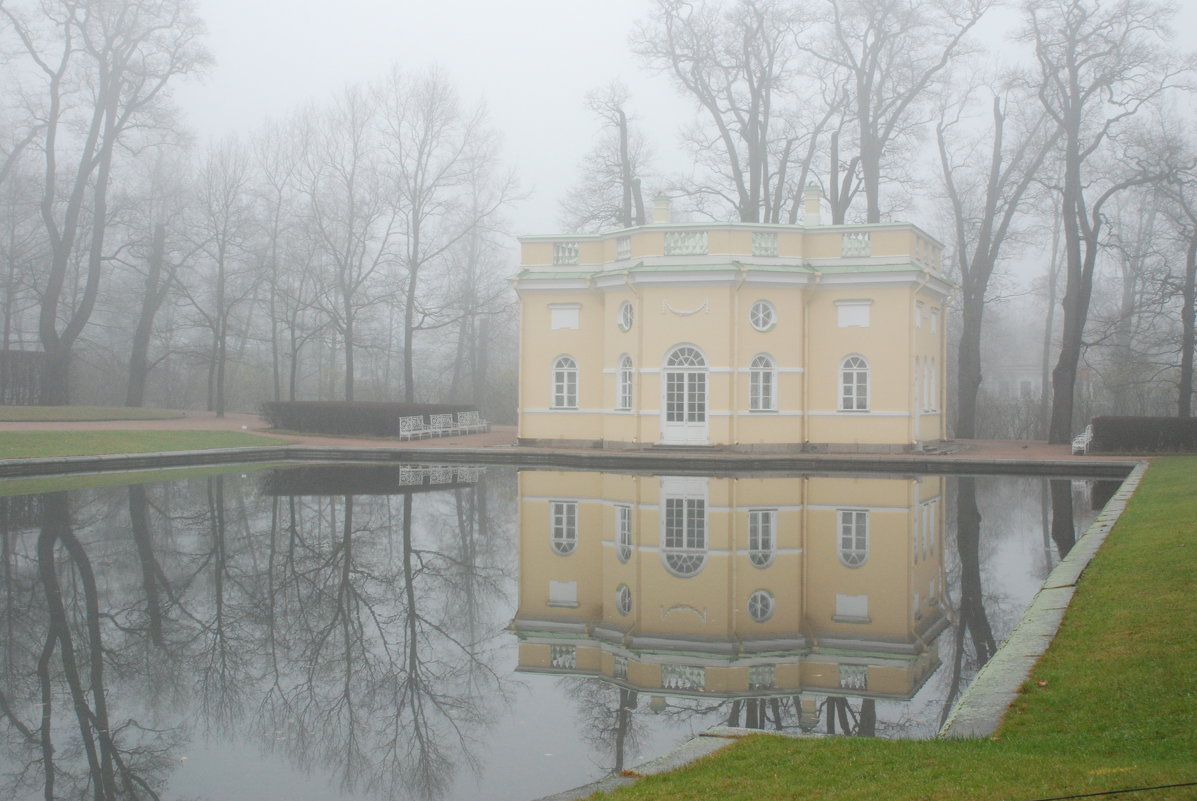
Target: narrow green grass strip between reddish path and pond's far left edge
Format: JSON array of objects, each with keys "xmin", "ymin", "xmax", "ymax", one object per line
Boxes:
[{"xmin": 0, "ymin": 431, "xmax": 288, "ymax": 459}]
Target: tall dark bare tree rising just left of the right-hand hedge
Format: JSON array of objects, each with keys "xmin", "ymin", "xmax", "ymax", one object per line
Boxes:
[{"xmin": 1023, "ymin": 0, "xmax": 1185, "ymax": 443}]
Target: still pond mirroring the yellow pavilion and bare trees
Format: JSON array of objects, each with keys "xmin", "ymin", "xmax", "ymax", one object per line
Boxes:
[{"xmin": 0, "ymin": 465, "xmax": 1111, "ymax": 801}]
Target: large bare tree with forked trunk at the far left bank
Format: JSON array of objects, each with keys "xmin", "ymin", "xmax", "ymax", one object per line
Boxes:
[{"xmin": 0, "ymin": 0, "xmax": 208, "ymax": 403}]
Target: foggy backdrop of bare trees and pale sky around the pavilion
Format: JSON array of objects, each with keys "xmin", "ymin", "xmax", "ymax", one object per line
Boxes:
[{"xmin": 0, "ymin": 0, "xmax": 1197, "ymax": 442}]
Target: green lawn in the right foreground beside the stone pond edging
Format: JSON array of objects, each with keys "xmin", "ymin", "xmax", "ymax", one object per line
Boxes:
[{"xmin": 593, "ymin": 456, "xmax": 1197, "ymax": 801}]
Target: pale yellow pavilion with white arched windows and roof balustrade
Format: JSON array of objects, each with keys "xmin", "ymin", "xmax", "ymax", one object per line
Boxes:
[{"xmin": 512, "ymin": 190, "xmax": 952, "ymax": 450}]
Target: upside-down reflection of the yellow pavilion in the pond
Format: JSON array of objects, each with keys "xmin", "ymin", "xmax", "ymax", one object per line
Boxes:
[{"xmin": 511, "ymin": 471, "xmax": 948, "ymax": 734}]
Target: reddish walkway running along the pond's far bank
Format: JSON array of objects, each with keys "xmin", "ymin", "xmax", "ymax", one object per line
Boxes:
[{"xmin": 0, "ymin": 412, "xmax": 1128, "ymax": 462}]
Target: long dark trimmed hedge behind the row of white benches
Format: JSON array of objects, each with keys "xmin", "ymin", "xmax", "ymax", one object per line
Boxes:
[{"xmin": 262, "ymin": 401, "xmax": 478, "ymax": 437}]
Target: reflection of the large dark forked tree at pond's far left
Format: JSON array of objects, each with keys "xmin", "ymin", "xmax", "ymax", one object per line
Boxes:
[{"xmin": 2, "ymin": 493, "xmax": 178, "ymax": 801}]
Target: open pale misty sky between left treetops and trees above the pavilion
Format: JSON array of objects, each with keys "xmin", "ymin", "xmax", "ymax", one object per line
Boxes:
[{"xmin": 176, "ymin": 0, "xmax": 691, "ymax": 233}]
